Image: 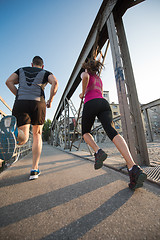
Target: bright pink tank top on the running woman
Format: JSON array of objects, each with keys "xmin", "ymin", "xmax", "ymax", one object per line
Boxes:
[{"xmin": 84, "ymin": 74, "xmax": 103, "ymax": 103}]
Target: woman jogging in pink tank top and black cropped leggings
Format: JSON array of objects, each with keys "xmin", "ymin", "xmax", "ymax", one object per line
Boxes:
[{"xmin": 79, "ymin": 59, "xmax": 147, "ymax": 190}]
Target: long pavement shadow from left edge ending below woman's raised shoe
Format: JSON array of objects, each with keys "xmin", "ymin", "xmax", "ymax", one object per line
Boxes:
[{"xmin": 0, "ymin": 173, "xmax": 118, "ymax": 227}]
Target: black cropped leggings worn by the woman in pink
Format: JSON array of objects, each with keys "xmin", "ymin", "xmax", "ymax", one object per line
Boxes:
[{"xmin": 82, "ymin": 98, "xmax": 118, "ymax": 141}]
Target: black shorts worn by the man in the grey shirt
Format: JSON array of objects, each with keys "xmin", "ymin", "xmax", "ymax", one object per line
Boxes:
[{"xmin": 12, "ymin": 100, "xmax": 46, "ymax": 127}]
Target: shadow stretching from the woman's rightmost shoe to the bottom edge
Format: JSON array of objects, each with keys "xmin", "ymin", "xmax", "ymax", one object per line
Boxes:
[{"xmin": 41, "ymin": 188, "xmax": 133, "ymax": 240}]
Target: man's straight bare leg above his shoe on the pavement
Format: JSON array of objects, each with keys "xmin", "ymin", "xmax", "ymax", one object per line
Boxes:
[{"xmin": 32, "ymin": 125, "xmax": 43, "ymax": 170}]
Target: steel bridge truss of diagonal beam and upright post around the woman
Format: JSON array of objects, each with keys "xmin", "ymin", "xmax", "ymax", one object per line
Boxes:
[{"xmin": 52, "ymin": 0, "xmax": 149, "ymax": 165}]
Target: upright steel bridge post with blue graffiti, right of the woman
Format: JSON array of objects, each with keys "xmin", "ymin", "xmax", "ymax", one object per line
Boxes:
[{"xmin": 107, "ymin": 13, "xmax": 149, "ymax": 165}]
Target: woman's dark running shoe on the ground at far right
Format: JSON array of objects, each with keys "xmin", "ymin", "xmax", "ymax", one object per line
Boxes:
[{"xmin": 128, "ymin": 165, "xmax": 147, "ymax": 190}]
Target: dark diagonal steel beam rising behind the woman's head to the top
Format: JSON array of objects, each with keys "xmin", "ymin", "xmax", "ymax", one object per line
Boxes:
[{"xmin": 52, "ymin": 0, "xmax": 118, "ymax": 127}]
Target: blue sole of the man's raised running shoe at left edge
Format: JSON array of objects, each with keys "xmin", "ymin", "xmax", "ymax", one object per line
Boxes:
[{"xmin": 0, "ymin": 116, "xmax": 16, "ymax": 161}]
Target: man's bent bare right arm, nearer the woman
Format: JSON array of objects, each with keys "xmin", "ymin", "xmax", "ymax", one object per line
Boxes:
[{"xmin": 46, "ymin": 74, "xmax": 58, "ymax": 108}]
